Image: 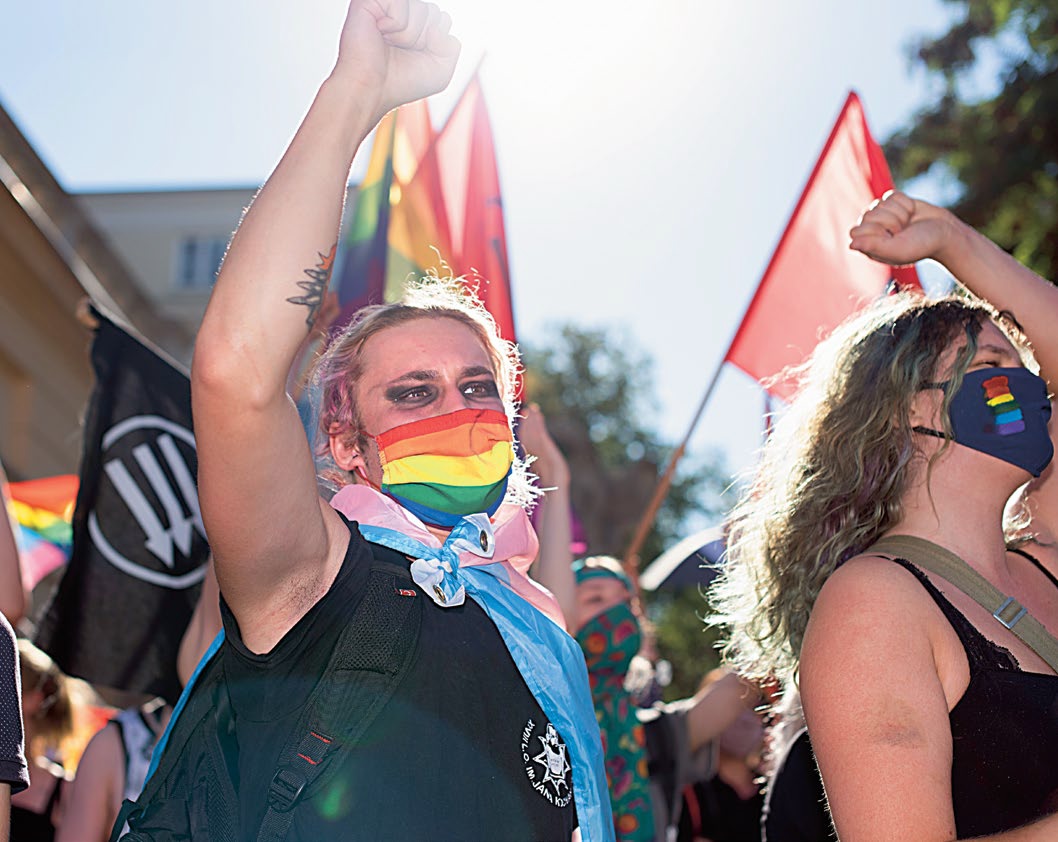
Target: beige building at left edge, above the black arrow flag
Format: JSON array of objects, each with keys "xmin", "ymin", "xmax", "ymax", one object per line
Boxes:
[{"xmin": 0, "ymin": 102, "xmax": 194, "ymax": 480}]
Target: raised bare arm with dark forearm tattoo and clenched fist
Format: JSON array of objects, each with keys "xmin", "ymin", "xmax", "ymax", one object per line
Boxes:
[{"xmin": 191, "ymin": 0, "xmax": 459, "ymax": 652}]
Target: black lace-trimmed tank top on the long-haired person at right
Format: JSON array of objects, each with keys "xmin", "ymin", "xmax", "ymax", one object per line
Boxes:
[{"xmin": 893, "ymin": 559, "xmax": 1058, "ymax": 839}]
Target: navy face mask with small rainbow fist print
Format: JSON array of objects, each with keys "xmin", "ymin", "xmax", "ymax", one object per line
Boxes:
[{"xmin": 912, "ymin": 368, "xmax": 1054, "ymax": 477}]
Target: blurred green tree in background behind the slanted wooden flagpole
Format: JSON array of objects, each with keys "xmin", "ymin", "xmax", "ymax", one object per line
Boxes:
[{"xmin": 522, "ymin": 325, "xmax": 733, "ymax": 699}]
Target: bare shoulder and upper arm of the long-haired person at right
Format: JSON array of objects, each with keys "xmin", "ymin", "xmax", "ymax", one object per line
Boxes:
[{"xmin": 800, "ymin": 556, "xmax": 957, "ymax": 839}]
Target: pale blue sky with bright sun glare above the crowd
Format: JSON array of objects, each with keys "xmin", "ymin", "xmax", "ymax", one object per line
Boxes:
[{"xmin": 0, "ymin": 0, "xmax": 969, "ymax": 526}]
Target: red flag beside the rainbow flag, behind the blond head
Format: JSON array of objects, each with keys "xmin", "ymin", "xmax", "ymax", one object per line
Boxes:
[{"xmin": 437, "ymin": 74, "xmax": 515, "ymax": 342}]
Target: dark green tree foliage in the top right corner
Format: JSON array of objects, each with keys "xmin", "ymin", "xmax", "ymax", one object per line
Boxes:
[{"xmin": 886, "ymin": 0, "xmax": 1058, "ymax": 280}]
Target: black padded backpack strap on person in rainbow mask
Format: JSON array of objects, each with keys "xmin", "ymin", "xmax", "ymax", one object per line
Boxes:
[{"xmin": 257, "ymin": 562, "xmax": 422, "ymax": 842}]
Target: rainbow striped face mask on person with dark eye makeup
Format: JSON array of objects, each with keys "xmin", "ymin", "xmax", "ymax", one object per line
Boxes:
[{"xmin": 375, "ymin": 409, "xmax": 514, "ymax": 527}]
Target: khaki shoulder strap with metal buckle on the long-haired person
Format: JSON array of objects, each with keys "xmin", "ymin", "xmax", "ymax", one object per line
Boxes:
[{"xmin": 864, "ymin": 535, "xmax": 1058, "ymax": 673}]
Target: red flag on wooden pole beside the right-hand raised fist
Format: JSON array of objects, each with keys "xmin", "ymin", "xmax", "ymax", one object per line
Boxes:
[{"xmin": 725, "ymin": 92, "xmax": 920, "ymax": 398}]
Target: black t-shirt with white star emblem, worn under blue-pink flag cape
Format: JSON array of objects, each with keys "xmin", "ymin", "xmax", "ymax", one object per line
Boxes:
[{"xmin": 222, "ymin": 522, "xmax": 577, "ymax": 842}]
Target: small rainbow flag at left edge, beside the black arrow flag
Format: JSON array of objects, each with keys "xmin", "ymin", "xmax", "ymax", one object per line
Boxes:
[{"xmin": 7, "ymin": 474, "xmax": 78, "ymax": 590}]
